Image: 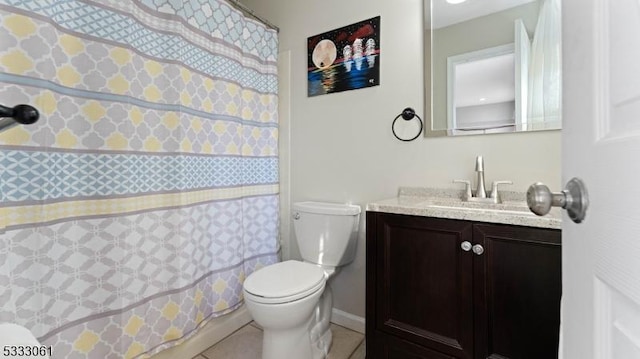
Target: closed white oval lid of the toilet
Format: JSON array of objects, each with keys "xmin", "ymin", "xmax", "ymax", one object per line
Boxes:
[{"xmin": 244, "ymin": 260, "xmax": 325, "ymax": 298}]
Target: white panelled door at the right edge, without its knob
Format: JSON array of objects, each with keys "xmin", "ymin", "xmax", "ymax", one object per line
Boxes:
[{"xmin": 561, "ymin": 0, "xmax": 640, "ymax": 359}]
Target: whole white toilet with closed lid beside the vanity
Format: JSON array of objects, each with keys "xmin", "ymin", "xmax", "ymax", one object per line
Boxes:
[{"xmin": 243, "ymin": 202, "xmax": 360, "ymax": 359}]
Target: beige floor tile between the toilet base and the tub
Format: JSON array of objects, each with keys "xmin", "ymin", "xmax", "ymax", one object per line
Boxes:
[{"xmin": 202, "ymin": 325, "xmax": 262, "ymax": 359}]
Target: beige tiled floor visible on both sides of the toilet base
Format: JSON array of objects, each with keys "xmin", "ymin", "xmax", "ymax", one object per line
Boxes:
[{"xmin": 193, "ymin": 322, "xmax": 365, "ymax": 359}]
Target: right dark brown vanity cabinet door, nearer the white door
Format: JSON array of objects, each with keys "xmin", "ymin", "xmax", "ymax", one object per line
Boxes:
[{"xmin": 473, "ymin": 224, "xmax": 562, "ymax": 359}]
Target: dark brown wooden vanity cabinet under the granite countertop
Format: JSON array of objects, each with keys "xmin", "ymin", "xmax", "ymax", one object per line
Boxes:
[{"xmin": 366, "ymin": 212, "xmax": 561, "ymax": 359}]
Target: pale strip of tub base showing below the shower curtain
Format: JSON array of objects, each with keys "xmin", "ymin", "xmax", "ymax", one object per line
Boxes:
[{"xmin": 151, "ymin": 305, "xmax": 251, "ymax": 359}]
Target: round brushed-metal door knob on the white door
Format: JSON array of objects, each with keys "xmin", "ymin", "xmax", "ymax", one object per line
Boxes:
[{"xmin": 527, "ymin": 177, "xmax": 589, "ymax": 223}]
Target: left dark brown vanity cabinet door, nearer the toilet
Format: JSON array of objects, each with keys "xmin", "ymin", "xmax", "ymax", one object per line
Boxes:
[{"xmin": 375, "ymin": 214, "xmax": 473, "ymax": 359}]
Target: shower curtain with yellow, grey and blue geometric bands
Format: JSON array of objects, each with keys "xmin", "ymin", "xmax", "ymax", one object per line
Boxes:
[{"xmin": 0, "ymin": 0, "xmax": 278, "ymax": 359}]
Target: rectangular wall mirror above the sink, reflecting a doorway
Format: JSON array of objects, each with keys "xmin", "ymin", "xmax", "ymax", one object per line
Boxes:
[{"xmin": 424, "ymin": 0, "xmax": 562, "ymax": 136}]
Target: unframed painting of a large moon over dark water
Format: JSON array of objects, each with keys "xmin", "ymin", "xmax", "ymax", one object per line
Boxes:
[{"xmin": 307, "ymin": 16, "xmax": 380, "ymax": 97}]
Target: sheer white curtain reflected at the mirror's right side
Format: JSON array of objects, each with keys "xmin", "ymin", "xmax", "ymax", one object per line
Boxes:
[{"xmin": 527, "ymin": 0, "xmax": 562, "ymax": 129}]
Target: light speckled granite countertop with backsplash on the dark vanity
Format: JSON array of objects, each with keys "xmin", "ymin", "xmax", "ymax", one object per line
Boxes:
[{"xmin": 367, "ymin": 187, "xmax": 562, "ymax": 229}]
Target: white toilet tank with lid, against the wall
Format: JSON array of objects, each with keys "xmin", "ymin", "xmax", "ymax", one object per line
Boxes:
[{"xmin": 293, "ymin": 202, "xmax": 361, "ymax": 267}]
